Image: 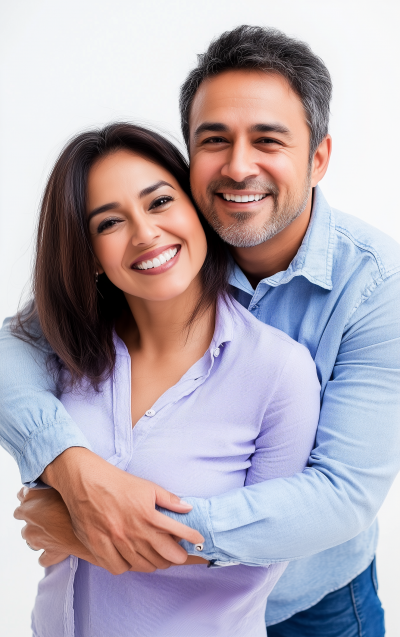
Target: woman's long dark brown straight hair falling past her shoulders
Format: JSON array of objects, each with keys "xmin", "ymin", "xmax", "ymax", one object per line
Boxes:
[{"xmin": 13, "ymin": 123, "xmax": 227, "ymax": 388}]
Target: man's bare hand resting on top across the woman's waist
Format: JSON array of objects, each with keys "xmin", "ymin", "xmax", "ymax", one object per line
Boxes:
[{"xmin": 42, "ymin": 447, "xmax": 204, "ymax": 575}]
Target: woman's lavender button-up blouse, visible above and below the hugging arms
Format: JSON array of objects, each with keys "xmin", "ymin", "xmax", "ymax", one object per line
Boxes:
[{"xmin": 32, "ymin": 301, "xmax": 320, "ymax": 637}]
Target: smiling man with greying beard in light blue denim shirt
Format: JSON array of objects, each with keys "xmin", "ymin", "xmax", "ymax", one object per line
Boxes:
[{"xmin": 0, "ymin": 26, "xmax": 400, "ymax": 637}]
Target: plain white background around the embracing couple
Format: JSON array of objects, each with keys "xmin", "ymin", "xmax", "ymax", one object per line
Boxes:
[{"xmin": 0, "ymin": 0, "xmax": 400, "ymax": 637}]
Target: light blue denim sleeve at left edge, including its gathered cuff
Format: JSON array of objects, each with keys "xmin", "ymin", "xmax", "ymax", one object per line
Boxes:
[{"xmin": 0, "ymin": 319, "xmax": 90, "ymax": 486}]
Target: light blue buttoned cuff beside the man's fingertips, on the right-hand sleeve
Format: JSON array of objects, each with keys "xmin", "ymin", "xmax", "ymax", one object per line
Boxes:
[{"xmin": 156, "ymin": 497, "xmax": 239, "ymax": 567}]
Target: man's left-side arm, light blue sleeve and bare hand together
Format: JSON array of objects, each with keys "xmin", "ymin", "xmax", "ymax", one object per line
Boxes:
[{"xmin": 0, "ymin": 318, "xmax": 203, "ymax": 573}]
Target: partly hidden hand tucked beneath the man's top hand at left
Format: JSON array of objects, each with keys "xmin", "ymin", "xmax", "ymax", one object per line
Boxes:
[{"xmin": 14, "ymin": 487, "xmax": 97, "ymax": 567}]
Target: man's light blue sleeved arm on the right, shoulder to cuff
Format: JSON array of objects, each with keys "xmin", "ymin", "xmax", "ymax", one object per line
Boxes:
[{"xmin": 161, "ymin": 274, "xmax": 400, "ymax": 565}]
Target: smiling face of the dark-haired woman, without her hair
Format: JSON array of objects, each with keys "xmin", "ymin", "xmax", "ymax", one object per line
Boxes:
[{"xmin": 87, "ymin": 150, "xmax": 207, "ymax": 301}]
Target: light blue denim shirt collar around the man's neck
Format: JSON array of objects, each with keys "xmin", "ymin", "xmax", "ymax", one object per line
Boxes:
[{"xmin": 229, "ymin": 186, "xmax": 335, "ymax": 296}]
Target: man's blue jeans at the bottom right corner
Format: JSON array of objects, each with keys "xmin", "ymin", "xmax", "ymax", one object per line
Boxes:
[{"xmin": 267, "ymin": 559, "xmax": 385, "ymax": 637}]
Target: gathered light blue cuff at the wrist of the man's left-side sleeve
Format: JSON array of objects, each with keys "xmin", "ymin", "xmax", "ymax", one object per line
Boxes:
[{"xmin": 17, "ymin": 421, "xmax": 91, "ymax": 488}]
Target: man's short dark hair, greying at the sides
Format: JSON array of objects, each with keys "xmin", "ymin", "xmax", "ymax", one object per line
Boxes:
[{"xmin": 179, "ymin": 25, "xmax": 332, "ymax": 158}]
